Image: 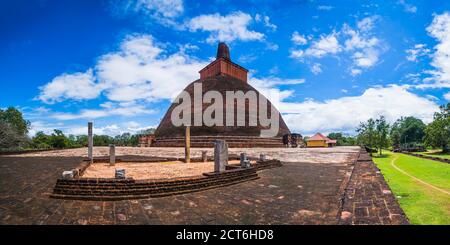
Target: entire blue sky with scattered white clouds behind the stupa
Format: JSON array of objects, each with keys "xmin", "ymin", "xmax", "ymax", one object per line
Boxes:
[{"xmin": 0, "ymin": 0, "xmax": 450, "ymax": 135}]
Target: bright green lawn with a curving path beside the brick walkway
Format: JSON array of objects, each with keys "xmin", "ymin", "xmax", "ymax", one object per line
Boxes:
[{"xmin": 373, "ymin": 152, "xmax": 450, "ymax": 225}]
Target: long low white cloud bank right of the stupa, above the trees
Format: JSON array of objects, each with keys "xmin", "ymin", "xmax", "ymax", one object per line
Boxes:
[{"xmin": 279, "ymin": 85, "xmax": 438, "ymax": 134}]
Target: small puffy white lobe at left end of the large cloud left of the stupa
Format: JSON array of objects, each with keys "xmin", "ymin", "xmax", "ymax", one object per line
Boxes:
[{"xmin": 37, "ymin": 69, "xmax": 101, "ymax": 104}]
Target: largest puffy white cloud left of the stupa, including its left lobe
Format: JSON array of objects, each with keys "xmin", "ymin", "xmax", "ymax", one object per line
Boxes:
[{"xmin": 38, "ymin": 35, "xmax": 207, "ymax": 103}]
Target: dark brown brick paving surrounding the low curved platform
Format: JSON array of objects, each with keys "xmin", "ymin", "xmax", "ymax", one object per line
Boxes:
[{"xmin": 0, "ymin": 148, "xmax": 408, "ymax": 224}]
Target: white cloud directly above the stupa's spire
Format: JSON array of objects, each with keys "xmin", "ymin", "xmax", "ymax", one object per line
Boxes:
[{"xmin": 187, "ymin": 11, "xmax": 264, "ymax": 43}]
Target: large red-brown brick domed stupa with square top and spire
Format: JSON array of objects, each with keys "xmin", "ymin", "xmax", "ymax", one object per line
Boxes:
[{"xmin": 152, "ymin": 43, "xmax": 290, "ymax": 147}]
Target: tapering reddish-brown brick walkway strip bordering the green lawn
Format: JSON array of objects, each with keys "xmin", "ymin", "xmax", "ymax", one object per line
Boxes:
[{"xmin": 339, "ymin": 152, "xmax": 409, "ymax": 225}]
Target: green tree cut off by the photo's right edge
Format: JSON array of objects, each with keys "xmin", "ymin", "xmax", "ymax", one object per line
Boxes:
[{"xmin": 425, "ymin": 103, "xmax": 450, "ymax": 153}]
